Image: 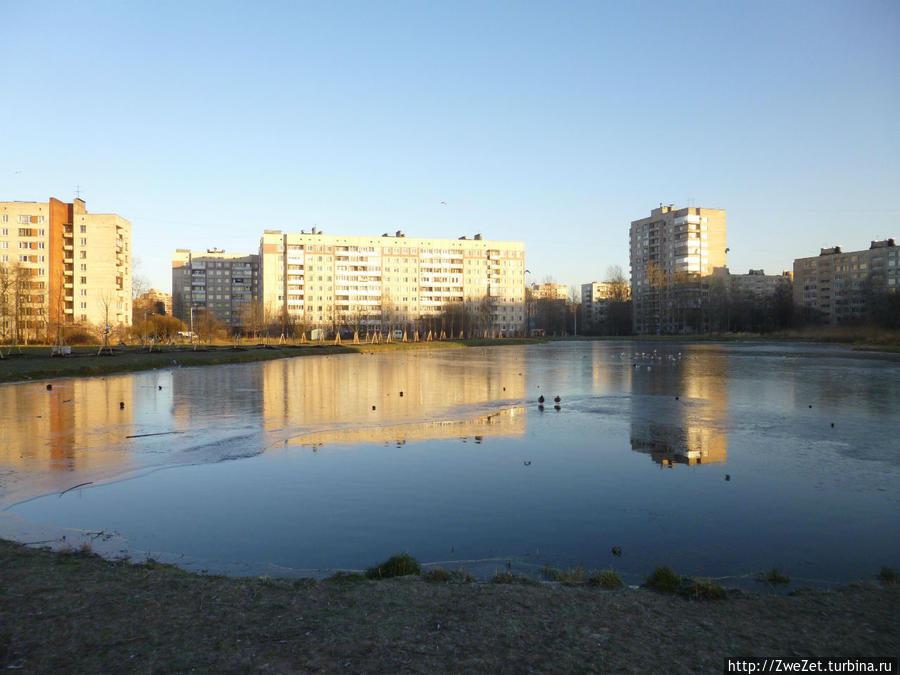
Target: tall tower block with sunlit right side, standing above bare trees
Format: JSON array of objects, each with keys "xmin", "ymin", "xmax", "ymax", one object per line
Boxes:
[{"xmin": 630, "ymin": 204, "xmax": 728, "ymax": 334}]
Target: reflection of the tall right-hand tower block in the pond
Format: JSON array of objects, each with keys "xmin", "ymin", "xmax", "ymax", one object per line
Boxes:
[{"xmin": 631, "ymin": 346, "xmax": 728, "ymax": 468}]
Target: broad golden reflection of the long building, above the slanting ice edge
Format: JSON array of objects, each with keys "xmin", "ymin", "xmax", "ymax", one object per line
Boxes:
[{"xmin": 262, "ymin": 353, "xmax": 526, "ymax": 442}]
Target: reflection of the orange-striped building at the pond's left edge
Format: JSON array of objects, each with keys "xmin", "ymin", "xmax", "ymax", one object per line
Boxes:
[{"xmin": 0, "ymin": 376, "xmax": 134, "ymax": 472}]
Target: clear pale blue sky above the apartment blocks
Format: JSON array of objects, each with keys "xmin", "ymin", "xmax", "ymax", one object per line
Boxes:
[{"xmin": 0, "ymin": 0, "xmax": 900, "ymax": 291}]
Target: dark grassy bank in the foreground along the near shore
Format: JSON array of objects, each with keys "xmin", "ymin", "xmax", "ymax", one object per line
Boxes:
[{"xmin": 0, "ymin": 541, "xmax": 900, "ymax": 672}]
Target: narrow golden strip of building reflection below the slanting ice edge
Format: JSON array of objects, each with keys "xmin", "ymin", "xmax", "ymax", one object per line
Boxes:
[{"xmin": 284, "ymin": 407, "xmax": 525, "ymax": 452}]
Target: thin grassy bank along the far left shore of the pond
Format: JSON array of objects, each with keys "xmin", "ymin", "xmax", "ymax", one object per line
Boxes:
[{"xmin": 0, "ymin": 339, "xmax": 537, "ymax": 382}]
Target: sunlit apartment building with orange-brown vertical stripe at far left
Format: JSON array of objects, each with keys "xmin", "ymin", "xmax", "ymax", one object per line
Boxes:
[{"xmin": 0, "ymin": 198, "xmax": 132, "ymax": 339}]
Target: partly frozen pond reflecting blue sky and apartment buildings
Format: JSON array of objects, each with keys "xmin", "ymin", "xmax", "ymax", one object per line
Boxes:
[{"xmin": 0, "ymin": 341, "xmax": 900, "ymax": 581}]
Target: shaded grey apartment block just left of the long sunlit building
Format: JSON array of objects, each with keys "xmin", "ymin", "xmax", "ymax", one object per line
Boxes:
[{"xmin": 172, "ymin": 248, "xmax": 259, "ymax": 326}]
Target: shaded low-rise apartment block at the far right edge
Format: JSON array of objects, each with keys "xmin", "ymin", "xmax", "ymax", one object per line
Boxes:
[{"xmin": 794, "ymin": 239, "xmax": 900, "ymax": 324}]
